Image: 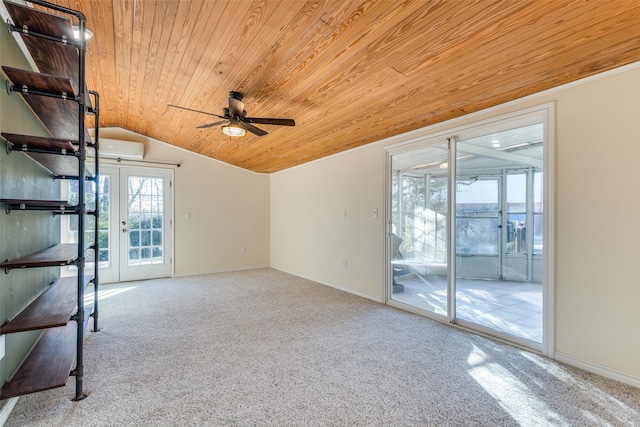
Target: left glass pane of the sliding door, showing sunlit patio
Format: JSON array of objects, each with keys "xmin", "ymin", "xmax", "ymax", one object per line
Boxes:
[{"xmin": 390, "ymin": 141, "xmax": 448, "ymax": 316}]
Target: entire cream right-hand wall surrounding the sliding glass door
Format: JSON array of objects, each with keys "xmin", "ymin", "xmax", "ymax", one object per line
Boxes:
[{"xmin": 271, "ymin": 64, "xmax": 640, "ymax": 384}]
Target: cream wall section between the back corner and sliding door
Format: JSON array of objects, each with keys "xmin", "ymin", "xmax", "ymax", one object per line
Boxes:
[{"xmin": 271, "ymin": 146, "xmax": 385, "ymax": 301}]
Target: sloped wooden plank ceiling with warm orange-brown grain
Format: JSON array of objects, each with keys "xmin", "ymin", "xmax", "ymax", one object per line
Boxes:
[{"xmin": 33, "ymin": 0, "xmax": 640, "ymax": 173}]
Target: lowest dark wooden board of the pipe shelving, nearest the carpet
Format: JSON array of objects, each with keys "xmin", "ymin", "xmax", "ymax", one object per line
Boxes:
[{"xmin": 0, "ymin": 322, "xmax": 77, "ymax": 399}]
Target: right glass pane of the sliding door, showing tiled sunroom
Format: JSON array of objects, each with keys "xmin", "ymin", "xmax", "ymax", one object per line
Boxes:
[{"xmin": 454, "ymin": 129, "xmax": 543, "ymax": 343}]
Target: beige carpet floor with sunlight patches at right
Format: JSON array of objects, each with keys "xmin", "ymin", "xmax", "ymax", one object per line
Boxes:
[{"xmin": 6, "ymin": 269, "xmax": 640, "ymax": 427}]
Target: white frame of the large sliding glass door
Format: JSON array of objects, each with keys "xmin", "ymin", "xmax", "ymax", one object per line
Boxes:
[{"xmin": 385, "ymin": 103, "xmax": 555, "ymax": 357}]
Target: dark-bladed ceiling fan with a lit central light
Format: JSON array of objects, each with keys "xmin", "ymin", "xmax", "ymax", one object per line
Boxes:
[{"xmin": 167, "ymin": 91, "xmax": 296, "ymax": 136}]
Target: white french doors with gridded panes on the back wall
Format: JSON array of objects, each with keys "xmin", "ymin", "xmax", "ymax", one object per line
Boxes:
[{"xmin": 63, "ymin": 165, "xmax": 173, "ymax": 283}]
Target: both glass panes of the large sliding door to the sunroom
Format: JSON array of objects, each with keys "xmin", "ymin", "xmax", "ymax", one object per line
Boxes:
[{"xmin": 388, "ymin": 105, "xmax": 550, "ymax": 350}]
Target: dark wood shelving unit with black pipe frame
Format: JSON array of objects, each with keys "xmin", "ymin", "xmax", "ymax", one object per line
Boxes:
[{"xmin": 0, "ymin": 0, "xmax": 99, "ymax": 400}]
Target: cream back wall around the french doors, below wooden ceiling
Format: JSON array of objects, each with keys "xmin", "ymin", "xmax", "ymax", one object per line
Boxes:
[{"xmin": 95, "ymin": 128, "xmax": 270, "ymax": 276}]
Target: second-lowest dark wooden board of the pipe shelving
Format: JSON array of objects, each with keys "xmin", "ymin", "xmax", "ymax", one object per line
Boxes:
[{"xmin": 0, "ymin": 275, "xmax": 92, "ymax": 334}]
